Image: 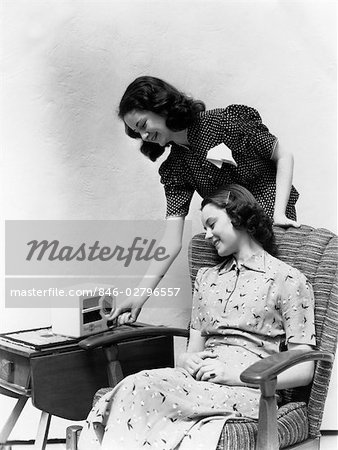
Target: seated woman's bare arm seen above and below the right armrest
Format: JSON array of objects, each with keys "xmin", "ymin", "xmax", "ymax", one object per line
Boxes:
[{"xmin": 277, "ymin": 344, "xmax": 314, "ymax": 389}]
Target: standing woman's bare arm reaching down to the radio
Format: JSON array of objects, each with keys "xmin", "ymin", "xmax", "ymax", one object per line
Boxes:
[{"xmin": 109, "ymin": 217, "xmax": 184, "ymax": 324}]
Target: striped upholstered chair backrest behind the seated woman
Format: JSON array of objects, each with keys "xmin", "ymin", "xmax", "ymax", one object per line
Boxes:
[{"xmin": 189, "ymin": 225, "xmax": 338, "ymax": 437}]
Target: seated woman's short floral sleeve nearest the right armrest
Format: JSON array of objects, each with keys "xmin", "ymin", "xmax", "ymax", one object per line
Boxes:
[{"xmin": 280, "ymin": 270, "xmax": 316, "ymax": 346}]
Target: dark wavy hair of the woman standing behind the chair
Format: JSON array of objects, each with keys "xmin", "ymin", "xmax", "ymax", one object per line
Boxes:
[{"xmin": 118, "ymin": 76, "xmax": 205, "ymax": 161}]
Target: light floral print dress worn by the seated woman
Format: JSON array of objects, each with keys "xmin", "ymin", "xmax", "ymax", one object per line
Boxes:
[{"xmin": 79, "ymin": 251, "xmax": 315, "ymax": 450}]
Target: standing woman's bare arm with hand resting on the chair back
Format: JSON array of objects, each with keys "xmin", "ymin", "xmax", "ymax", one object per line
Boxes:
[{"xmin": 271, "ymin": 143, "xmax": 299, "ymax": 227}]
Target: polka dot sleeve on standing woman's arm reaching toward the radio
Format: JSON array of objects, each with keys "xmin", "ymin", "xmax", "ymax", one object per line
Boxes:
[{"xmin": 159, "ymin": 150, "xmax": 194, "ymax": 217}]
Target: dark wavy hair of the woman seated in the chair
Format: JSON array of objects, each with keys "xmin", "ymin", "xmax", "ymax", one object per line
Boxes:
[{"xmin": 201, "ymin": 184, "xmax": 277, "ymax": 255}]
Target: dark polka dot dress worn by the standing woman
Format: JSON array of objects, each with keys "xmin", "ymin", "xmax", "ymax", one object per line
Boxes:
[{"xmin": 159, "ymin": 105, "xmax": 299, "ymax": 220}]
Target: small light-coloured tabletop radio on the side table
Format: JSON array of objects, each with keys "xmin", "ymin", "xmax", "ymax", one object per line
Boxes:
[{"xmin": 51, "ymin": 286, "xmax": 116, "ymax": 337}]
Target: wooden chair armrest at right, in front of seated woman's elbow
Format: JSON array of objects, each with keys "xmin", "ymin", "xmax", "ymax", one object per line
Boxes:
[{"xmin": 240, "ymin": 350, "xmax": 333, "ymax": 384}]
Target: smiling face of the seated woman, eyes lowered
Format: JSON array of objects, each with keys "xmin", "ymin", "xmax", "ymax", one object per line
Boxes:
[{"xmin": 202, "ymin": 203, "xmax": 241, "ymax": 256}]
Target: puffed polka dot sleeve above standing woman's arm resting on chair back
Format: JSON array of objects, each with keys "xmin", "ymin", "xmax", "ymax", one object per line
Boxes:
[{"xmin": 223, "ymin": 105, "xmax": 278, "ymax": 159}]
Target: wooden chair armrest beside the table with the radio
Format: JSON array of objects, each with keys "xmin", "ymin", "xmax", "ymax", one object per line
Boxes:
[{"xmin": 78, "ymin": 322, "xmax": 189, "ymax": 350}]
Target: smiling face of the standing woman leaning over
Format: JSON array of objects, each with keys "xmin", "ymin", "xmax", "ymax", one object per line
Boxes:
[{"xmin": 123, "ymin": 110, "xmax": 172, "ymax": 147}]
